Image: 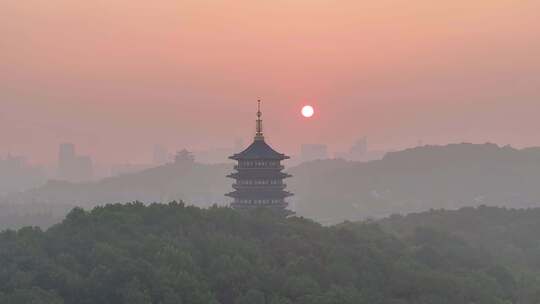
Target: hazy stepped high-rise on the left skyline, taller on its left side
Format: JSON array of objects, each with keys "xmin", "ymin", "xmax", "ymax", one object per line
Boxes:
[{"xmin": 58, "ymin": 143, "xmax": 93, "ymax": 182}]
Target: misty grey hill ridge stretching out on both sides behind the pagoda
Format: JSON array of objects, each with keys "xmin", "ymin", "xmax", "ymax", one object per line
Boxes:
[{"xmin": 0, "ymin": 144, "xmax": 540, "ymax": 228}]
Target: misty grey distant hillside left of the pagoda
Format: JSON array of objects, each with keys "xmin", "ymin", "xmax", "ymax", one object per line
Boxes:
[{"xmin": 0, "ymin": 162, "xmax": 232, "ymax": 229}]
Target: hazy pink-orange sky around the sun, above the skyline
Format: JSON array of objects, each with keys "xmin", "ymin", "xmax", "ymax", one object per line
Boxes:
[{"xmin": 0, "ymin": 0, "xmax": 540, "ymax": 162}]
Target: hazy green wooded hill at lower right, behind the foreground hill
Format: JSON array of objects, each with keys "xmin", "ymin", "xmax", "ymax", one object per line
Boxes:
[{"xmin": 342, "ymin": 206, "xmax": 540, "ymax": 303}]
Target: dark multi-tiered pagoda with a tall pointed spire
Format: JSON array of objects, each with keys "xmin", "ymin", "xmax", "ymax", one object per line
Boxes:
[{"xmin": 226, "ymin": 101, "xmax": 293, "ymax": 213}]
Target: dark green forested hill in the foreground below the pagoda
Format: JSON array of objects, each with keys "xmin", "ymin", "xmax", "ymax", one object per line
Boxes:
[{"xmin": 0, "ymin": 203, "xmax": 516, "ymax": 304}]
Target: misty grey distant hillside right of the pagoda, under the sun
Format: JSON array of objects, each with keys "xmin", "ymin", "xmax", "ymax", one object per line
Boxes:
[{"xmin": 290, "ymin": 144, "xmax": 540, "ymax": 223}]
